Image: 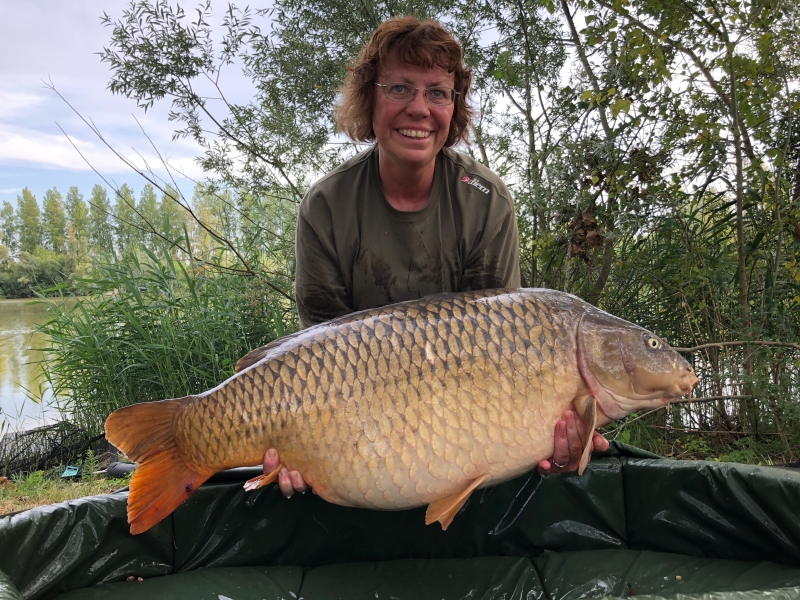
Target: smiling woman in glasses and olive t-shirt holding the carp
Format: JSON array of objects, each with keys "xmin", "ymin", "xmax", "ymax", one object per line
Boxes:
[{"xmin": 263, "ymin": 17, "xmax": 608, "ymax": 497}]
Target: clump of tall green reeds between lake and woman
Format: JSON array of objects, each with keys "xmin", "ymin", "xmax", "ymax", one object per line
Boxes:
[{"xmin": 39, "ymin": 250, "xmax": 297, "ymax": 435}]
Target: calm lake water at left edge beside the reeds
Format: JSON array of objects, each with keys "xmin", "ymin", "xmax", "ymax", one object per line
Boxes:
[{"xmin": 0, "ymin": 299, "xmax": 58, "ymax": 429}]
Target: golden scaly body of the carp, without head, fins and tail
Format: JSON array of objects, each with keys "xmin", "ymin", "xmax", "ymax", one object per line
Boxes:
[{"xmin": 180, "ymin": 293, "xmax": 582, "ymax": 510}]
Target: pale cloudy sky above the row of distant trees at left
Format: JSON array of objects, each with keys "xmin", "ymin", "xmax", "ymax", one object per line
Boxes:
[{"xmin": 0, "ymin": 0, "xmax": 220, "ymax": 206}]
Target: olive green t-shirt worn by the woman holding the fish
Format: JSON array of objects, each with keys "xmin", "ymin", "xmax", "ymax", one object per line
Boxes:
[{"xmin": 295, "ymin": 146, "xmax": 520, "ymax": 327}]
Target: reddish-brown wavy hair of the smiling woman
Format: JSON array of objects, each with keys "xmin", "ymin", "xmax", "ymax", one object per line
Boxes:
[{"xmin": 336, "ymin": 17, "xmax": 472, "ymax": 147}]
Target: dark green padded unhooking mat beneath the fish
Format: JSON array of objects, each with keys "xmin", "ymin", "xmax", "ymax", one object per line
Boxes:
[{"xmin": 0, "ymin": 444, "xmax": 800, "ymax": 600}]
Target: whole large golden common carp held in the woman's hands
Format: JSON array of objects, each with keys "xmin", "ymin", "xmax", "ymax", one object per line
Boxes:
[{"xmin": 106, "ymin": 289, "xmax": 697, "ymax": 534}]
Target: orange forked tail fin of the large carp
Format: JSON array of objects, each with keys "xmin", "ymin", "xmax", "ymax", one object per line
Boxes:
[{"xmin": 106, "ymin": 398, "xmax": 213, "ymax": 535}]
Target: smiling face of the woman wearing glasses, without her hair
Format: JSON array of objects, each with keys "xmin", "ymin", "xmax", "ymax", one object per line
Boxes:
[{"xmin": 372, "ymin": 61, "xmax": 454, "ymax": 168}]
